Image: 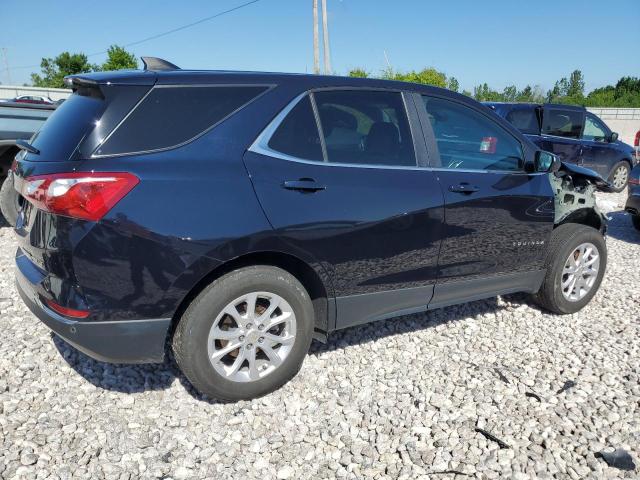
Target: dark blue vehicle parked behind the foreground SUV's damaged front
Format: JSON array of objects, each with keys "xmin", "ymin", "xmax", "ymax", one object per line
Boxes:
[{"xmin": 485, "ymin": 102, "xmax": 638, "ymax": 192}]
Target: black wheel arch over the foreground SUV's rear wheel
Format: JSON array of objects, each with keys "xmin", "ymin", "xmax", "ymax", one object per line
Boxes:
[{"xmin": 169, "ymin": 251, "xmax": 335, "ymax": 340}]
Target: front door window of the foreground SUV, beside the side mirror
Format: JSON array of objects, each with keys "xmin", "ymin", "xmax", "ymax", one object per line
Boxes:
[{"xmin": 422, "ymin": 95, "xmax": 524, "ymax": 171}]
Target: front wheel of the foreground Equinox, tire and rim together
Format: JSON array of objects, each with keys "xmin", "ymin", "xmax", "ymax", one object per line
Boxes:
[{"xmin": 536, "ymin": 223, "xmax": 607, "ymax": 314}]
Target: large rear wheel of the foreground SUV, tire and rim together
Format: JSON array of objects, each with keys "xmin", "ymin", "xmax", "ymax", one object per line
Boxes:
[{"xmin": 173, "ymin": 266, "xmax": 314, "ymax": 401}]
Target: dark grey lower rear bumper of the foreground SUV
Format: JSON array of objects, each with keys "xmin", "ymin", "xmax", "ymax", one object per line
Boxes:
[{"xmin": 16, "ymin": 253, "xmax": 171, "ymax": 363}]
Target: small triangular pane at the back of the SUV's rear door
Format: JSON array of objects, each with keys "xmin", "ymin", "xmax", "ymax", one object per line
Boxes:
[{"xmin": 268, "ymin": 96, "xmax": 323, "ymax": 162}]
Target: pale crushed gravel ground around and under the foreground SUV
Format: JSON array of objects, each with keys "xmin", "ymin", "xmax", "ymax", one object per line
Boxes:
[{"xmin": 0, "ymin": 189, "xmax": 640, "ymax": 479}]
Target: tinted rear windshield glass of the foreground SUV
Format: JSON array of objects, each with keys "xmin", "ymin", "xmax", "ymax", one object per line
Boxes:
[{"xmin": 29, "ymin": 93, "xmax": 106, "ymax": 162}]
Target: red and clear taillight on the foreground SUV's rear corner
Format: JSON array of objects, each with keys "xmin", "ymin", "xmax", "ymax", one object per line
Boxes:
[{"xmin": 20, "ymin": 172, "xmax": 139, "ymax": 222}]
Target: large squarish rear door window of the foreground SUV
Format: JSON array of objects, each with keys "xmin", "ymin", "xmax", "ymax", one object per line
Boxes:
[{"xmin": 313, "ymin": 90, "xmax": 416, "ymax": 166}]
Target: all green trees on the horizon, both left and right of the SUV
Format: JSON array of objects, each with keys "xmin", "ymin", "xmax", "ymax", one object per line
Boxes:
[{"xmin": 25, "ymin": 45, "xmax": 640, "ymax": 108}]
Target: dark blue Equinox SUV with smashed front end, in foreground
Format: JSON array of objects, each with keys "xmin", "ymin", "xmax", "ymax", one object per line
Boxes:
[{"xmin": 12, "ymin": 59, "xmax": 607, "ymax": 399}]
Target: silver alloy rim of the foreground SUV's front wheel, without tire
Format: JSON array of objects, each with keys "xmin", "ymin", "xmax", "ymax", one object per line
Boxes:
[{"xmin": 562, "ymin": 243, "xmax": 600, "ymax": 302}]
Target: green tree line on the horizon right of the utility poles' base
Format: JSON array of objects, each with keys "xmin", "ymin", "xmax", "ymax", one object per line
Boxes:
[{"xmin": 349, "ymin": 68, "xmax": 640, "ymax": 108}]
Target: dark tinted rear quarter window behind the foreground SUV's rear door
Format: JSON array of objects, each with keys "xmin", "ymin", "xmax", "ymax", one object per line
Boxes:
[{"xmin": 96, "ymin": 86, "xmax": 267, "ymax": 155}]
